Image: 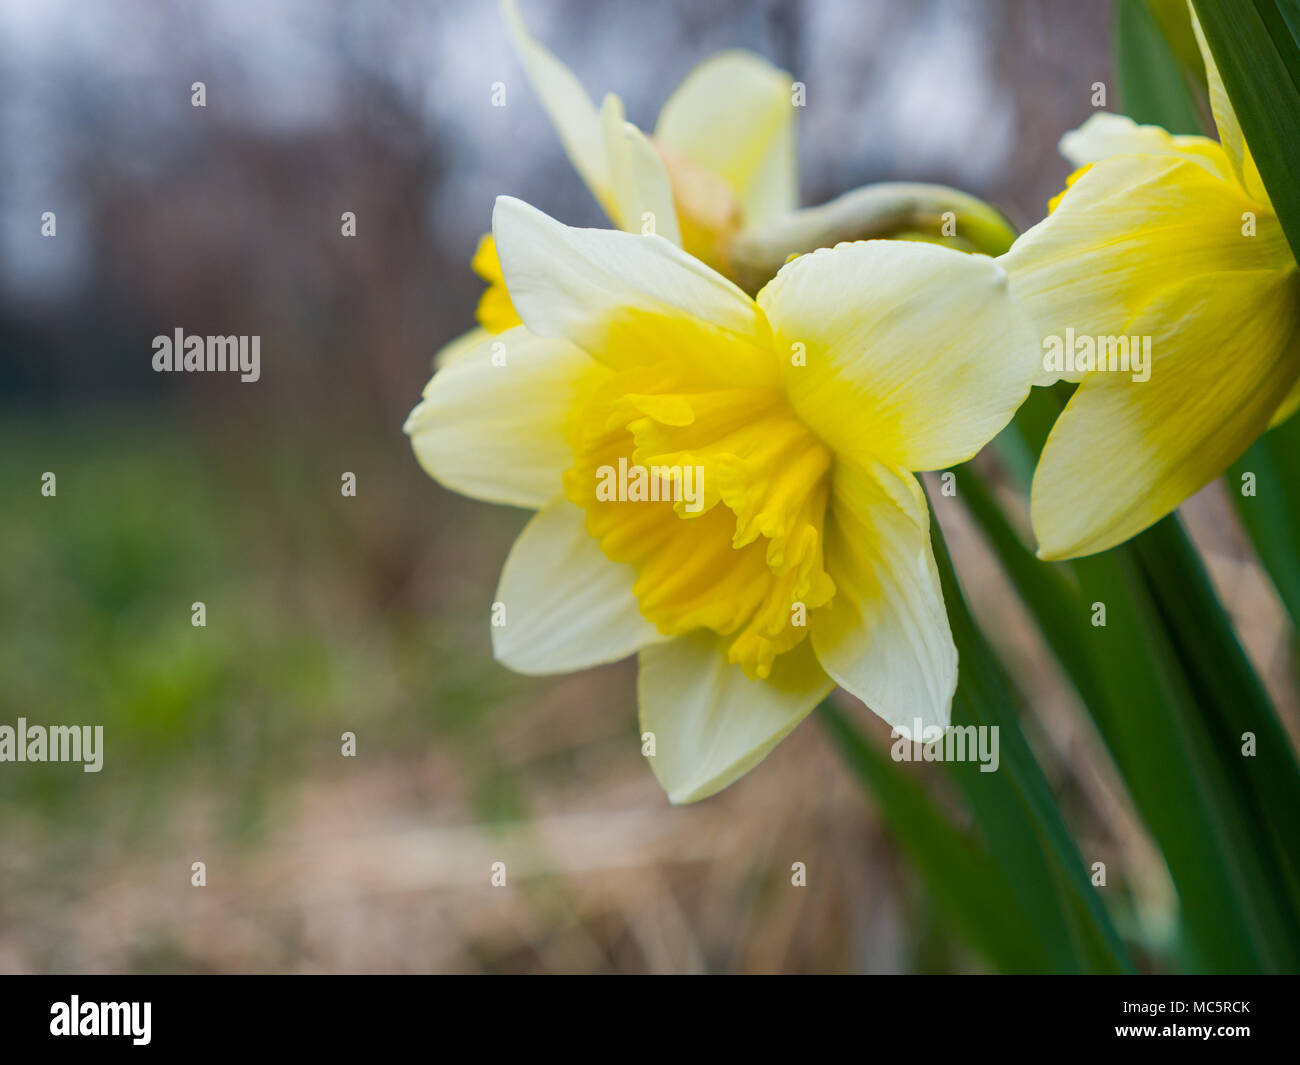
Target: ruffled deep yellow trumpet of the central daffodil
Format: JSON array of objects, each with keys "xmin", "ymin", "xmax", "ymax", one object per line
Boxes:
[{"xmin": 564, "ymin": 315, "xmax": 835, "ymax": 677}]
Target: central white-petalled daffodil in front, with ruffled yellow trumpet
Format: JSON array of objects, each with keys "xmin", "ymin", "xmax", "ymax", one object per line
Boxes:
[{"xmin": 406, "ymin": 198, "xmax": 1036, "ymax": 802}]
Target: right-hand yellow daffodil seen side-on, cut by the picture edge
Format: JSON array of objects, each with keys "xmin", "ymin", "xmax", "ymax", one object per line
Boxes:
[{"xmin": 1000, "ymin": 12, "xmax": 1300, "ymax": 559}]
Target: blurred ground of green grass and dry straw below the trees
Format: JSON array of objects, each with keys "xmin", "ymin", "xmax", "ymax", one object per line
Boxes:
[{"xmin": 0, "ymin": 411, "xmax": 904, "ymax": 973}]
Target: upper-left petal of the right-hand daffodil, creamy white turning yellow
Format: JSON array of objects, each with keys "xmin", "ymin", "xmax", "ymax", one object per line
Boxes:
[{"xmin": 998, "ymin": 155, "xmax": 1294, "ymax": 384}]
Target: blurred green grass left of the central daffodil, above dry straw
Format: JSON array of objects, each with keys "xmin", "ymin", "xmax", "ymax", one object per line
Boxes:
[{"xmin": 0, "ymin": 416, "xmax": 533, "ymax": 835}]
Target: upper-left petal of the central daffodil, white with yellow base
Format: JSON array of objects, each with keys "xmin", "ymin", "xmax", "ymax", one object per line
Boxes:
[{"xmin": 493, "ymin": 196, "xmax": 776, "ymax": 385}]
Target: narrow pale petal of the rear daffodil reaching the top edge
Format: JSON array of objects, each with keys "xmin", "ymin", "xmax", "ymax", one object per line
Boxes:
[{"xmin": 501, "ymin": 0, "xmax": 615, "ymax": 217}]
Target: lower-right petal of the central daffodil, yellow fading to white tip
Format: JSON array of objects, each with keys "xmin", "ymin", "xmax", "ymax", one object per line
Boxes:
[{"xmin": 811, "ymin": 459, "xmax": 957, "ymax": 737}]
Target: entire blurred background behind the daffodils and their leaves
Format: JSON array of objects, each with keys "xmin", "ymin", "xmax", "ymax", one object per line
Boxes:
[{"xmin": 0, "ymin": 0, "xmax": 1296, "ymax": 973}]
